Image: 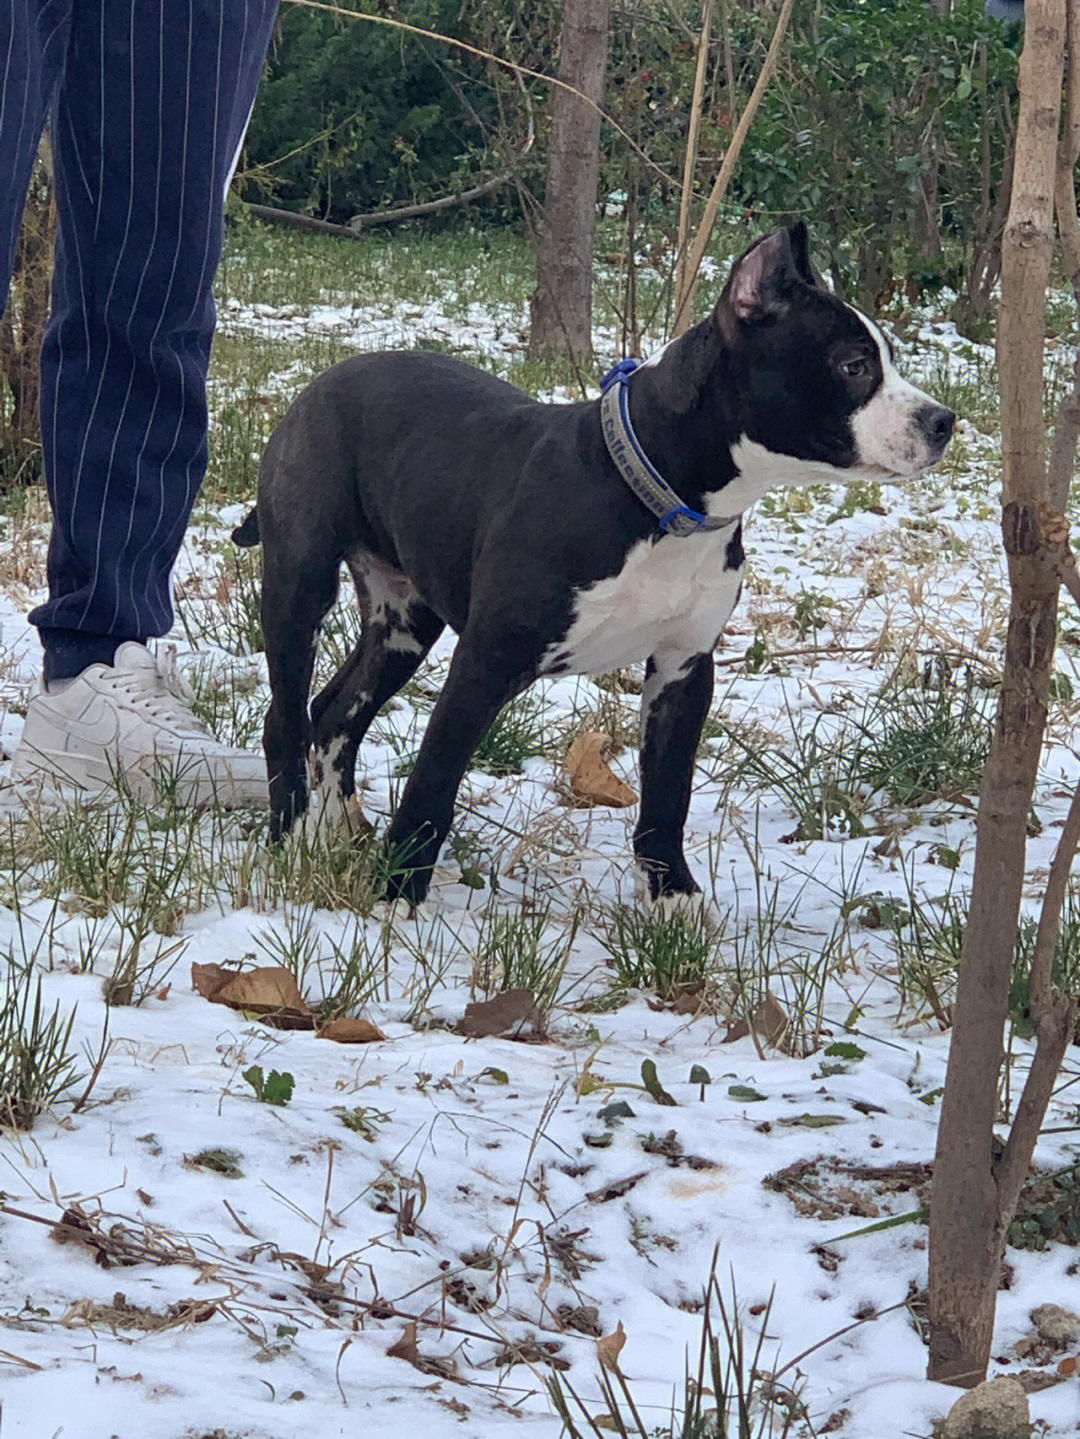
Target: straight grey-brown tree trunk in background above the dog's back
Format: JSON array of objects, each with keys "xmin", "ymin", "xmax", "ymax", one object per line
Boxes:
[{"xmin": 529, "ymin": 0, "xmax": 610, "ymax": 363}]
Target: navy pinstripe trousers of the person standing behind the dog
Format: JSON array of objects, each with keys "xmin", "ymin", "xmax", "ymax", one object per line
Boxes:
[{"xmin": 0, "ymin": 0, "xmax": 278, "ymax": 679}]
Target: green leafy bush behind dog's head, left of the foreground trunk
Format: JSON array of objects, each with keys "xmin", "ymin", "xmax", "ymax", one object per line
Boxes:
[{"xmin": 735, "ymin": 0, "xmax": 1018, "ymax": 318}]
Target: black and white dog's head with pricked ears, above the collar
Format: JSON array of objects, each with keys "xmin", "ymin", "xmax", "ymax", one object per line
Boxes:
[{"xmin": 713, "ymin": 224, "xmax": 956, "ymax": 484}]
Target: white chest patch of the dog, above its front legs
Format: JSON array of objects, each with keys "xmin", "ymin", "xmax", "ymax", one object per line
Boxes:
[{"xmin": 541, "ymin": 528, "xmax": 742, "ymax": 675}]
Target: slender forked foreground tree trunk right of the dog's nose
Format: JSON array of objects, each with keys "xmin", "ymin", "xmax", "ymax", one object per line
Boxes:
[{"xmin": 929, "ymin": 0, "xmax": 1074, "ymax": 1384}]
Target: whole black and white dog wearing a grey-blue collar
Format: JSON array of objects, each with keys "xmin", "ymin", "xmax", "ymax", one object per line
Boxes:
[{"xmin": 234, "ymin": 224, "xmax": 955, "ymax": 904}]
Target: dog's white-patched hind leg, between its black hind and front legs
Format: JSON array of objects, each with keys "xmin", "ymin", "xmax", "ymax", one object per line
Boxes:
[{"xmin": 301, "ymin": 551, "xmax": 444, "ymax": 830}]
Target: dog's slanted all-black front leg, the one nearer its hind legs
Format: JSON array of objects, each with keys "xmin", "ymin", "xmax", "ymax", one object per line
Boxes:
[{"xmin": 387, "ymin": 635, "xmax": 523, "ymax": 905}]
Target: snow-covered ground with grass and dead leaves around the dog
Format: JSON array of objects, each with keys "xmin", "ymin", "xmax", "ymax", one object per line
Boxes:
[{"xmin": 0, "ymin": 261, "xmax": 1080, "ymax": 1439}]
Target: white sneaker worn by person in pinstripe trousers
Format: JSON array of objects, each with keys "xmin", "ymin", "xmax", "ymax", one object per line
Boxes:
[{"xmin": 12, "ymin": 640, "xmax": 269, "ymax": 809}]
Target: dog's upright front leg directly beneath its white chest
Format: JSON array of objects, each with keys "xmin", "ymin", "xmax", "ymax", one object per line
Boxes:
[{"xmin": 634, "ymin": 653, "xmax": 713, "ymax": 899}]
